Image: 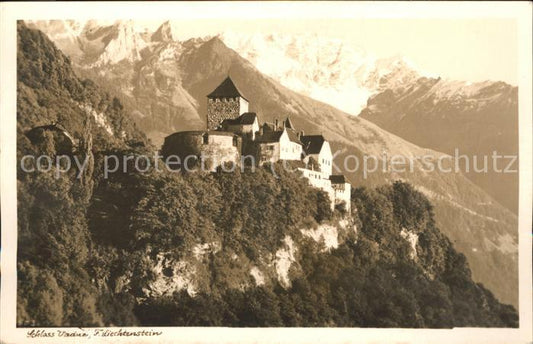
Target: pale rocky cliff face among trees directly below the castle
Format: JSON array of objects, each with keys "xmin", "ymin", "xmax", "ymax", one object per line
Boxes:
[{"xmin": 136, "ymin": 219, "xmax": 357, "ymax": 301}]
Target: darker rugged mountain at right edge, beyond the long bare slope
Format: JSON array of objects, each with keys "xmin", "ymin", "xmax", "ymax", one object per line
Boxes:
[{"xmin": 360, "ymin": 78, "xmax": 518, "ymax": 213}]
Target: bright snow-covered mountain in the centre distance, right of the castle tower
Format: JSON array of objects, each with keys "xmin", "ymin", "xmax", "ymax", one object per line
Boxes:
[{"xmin": 219, "ymin": 32, "xmax": 420, "ymax": 115}]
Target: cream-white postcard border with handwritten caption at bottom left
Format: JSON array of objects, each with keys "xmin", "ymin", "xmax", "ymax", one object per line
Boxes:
[{"xmin": 0, "ymin": 2, "xmax": 533, "ymax": 343}]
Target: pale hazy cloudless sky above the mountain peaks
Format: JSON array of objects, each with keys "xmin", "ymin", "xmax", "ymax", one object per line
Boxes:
[{"xmin": 136, "ymin": 18, "xmax": 518, "ymax": 85}]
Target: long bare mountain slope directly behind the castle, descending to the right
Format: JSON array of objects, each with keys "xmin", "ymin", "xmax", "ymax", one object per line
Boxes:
[{"xmin": 28, "ymin": 22, "xmax": 518, "ymax": 305}]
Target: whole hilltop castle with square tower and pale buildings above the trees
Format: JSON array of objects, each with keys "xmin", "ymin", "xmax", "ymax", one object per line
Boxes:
[{"xmin": 161, "ymin": 77, "xmax": 351, "ymax": 211}]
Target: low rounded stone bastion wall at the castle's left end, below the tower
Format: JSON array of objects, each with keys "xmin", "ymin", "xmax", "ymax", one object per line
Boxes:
[{"xmin": 161, "ymin": 131, "xmax": 241, "ymax": 172}]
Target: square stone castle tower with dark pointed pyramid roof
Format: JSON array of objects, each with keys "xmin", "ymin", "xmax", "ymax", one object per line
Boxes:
[{"xmin": 207, "ymin": 76, "xmax": 248, "ymax": 130}]
